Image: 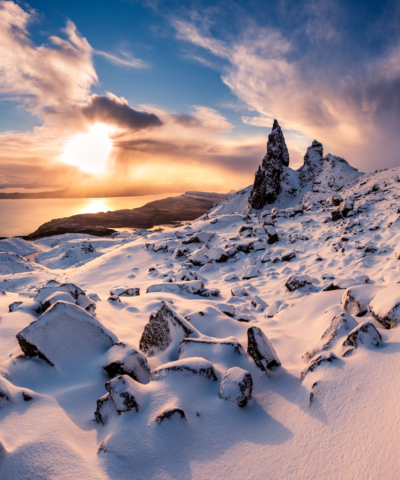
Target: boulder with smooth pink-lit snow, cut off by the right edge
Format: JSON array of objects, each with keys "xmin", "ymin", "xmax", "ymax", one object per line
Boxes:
[{"xmin": 369, "ymin": 283, "xmax": 400, "ymax": 328}]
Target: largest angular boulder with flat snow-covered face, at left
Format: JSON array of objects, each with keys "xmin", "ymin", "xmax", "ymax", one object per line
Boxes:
[{"xmin": 17, "ymin": 302, "xmax": 117, "ymax": 368}]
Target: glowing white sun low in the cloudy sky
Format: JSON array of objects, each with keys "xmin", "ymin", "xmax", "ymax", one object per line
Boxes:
[{"xmin": 61, "ymin": 123, "xmax": 114, "ymax": 173}]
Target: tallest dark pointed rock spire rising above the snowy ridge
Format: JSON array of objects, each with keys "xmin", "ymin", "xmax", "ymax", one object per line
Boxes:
[{"xmin": 249, "ymin": 120, "xmax": 289, "ymax": 209}]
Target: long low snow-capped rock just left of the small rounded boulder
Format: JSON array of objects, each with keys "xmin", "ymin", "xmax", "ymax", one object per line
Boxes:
[{"xmin": 151, "ymin": 357, "xmax": 218, "ymax": 382}]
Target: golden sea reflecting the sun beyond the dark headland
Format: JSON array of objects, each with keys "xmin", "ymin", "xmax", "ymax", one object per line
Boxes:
[{"xmin": 0, "ymin": 193, "xmax": 181, "ymax": 237}]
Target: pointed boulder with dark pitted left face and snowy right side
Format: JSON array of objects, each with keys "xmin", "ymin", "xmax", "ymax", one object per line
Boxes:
[{"xmin": 139, "ymin": 302, "xmax": 195, "ymax": 360}]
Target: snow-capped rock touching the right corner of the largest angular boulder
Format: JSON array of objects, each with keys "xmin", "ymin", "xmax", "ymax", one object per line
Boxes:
[{"xmin": 103, "ymin": 342, "xmax": 150, "ymax": 383}]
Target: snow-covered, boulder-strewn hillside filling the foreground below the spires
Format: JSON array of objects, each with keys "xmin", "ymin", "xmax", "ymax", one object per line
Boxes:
[{"xmin": 0, "ymin": 168, "xmax": 400, "ymax": 480}]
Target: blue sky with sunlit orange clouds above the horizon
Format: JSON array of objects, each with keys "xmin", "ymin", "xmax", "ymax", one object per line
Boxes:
[{"xmin": 0, "ymin": 0, "xmax": 400, "ymax": 193}]
